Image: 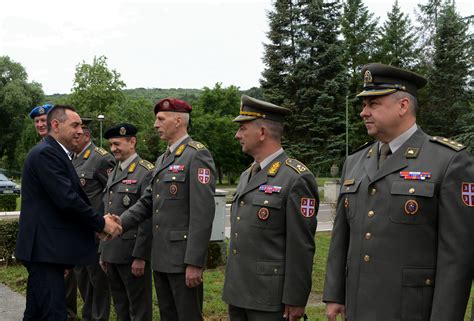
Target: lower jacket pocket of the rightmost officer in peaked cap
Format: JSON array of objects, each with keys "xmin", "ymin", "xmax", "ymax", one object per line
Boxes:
[{"xmin": 401, "ymin": 268, "xmax": 436, "ymax": 321}]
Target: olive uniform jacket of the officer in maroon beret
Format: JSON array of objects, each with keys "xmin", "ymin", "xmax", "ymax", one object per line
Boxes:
[{"xmin": 122, "ymin": 138, "xmax": 216, "ymax": 273}]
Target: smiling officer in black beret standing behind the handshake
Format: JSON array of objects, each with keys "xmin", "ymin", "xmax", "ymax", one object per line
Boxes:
[{"xmin": 100, "ymin": 124, "xmax": 154, "ymax": 321}]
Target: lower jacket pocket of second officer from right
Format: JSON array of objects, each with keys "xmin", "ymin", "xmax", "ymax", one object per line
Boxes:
[{"xmin": 254, "ymin": 262, "xmax": 285, "ymax": 305}]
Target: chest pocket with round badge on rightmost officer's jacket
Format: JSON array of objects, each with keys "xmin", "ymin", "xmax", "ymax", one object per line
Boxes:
[{"xmin": 389, "ymin": 180, "xmax": 438, "ymax": 224}]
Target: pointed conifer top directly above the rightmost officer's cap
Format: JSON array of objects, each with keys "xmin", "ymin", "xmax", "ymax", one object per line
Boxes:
[{"xmin": 374, "ymin": 0, "xmax": 419, "ymax": 69}]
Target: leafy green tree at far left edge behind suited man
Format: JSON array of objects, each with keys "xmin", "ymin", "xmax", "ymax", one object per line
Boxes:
[{"xmin": 0, "ymin": 56, "xmax": 44, "ymax": 169}]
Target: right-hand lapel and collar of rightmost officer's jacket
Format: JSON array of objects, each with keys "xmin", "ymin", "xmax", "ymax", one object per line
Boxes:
[{"xmin": 373, "ymin": 129, "xmax": 425, "ymax": 181}]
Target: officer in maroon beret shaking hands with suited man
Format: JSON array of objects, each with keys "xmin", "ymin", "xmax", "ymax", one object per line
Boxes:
[{"xmin": 117, "ymin": 98, "xmax": 216, "ymax": 321}]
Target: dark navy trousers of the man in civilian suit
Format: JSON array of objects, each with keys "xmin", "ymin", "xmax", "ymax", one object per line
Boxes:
[{"xmin": 23, "ymin": 262, "xmax": 67, "ymax": 321}]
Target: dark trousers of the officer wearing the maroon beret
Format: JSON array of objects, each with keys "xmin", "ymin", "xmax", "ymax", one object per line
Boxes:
[{"xmin": 153, "ymin": 271, "xmax": 204, "ymax": 321}]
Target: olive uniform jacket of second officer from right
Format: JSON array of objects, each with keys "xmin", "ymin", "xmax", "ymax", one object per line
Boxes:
[{"xmin": 222, "ymin": 153, "xmax": 319, "ymax": 311}]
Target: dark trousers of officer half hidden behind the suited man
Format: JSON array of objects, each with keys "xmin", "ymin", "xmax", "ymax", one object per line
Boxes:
[{"xmin": 74, "ymin": 257, "xmax": 110, "ymax": 321}]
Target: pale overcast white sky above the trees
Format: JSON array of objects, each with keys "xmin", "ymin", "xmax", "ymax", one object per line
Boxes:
[{"xmin": 0, "ymin": 0, "xmax": 474, "ymax": 94}]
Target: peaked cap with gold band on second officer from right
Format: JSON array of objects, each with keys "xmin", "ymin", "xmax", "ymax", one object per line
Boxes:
[{"xmin": 234, "ymin": 95, "xmax": 291, "ymax": 123}]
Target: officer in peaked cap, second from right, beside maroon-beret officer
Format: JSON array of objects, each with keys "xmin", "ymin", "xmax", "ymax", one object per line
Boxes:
[{"xmin": 223, "ymin": 95, "xmax": 319, "ymax": 321}]
